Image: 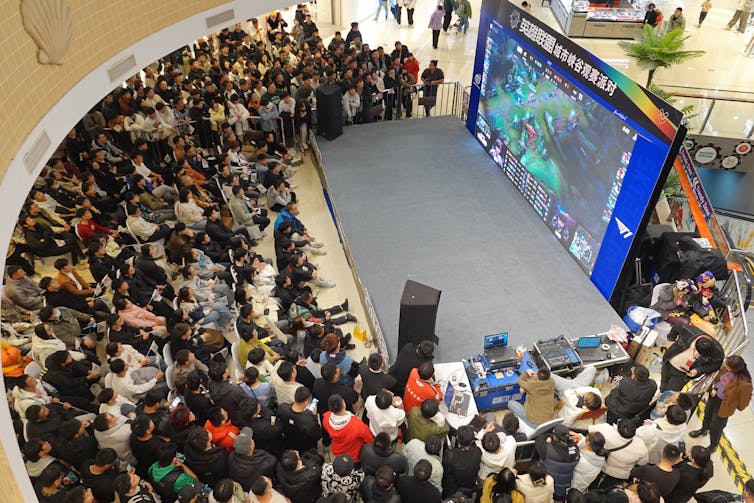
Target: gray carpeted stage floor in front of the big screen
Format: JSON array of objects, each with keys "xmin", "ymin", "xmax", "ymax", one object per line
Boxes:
[{"xmin": 319, "ymin": 117, "xmax": 622, "ymax": 361}]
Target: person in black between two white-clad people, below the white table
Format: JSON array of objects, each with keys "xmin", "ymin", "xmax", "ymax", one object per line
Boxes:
[{"xmin": 442, "ymin": 426, "xmax": 482, "ymax": 498}]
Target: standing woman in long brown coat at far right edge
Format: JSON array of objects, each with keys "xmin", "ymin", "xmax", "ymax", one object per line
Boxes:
[{"xmin": 689, "ymin": 355, "xmax": 752, "ymax": 452}]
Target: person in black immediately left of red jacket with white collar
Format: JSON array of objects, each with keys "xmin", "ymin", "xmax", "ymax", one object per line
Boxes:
[{"xmin": 277, "ymin": 386, "xmax": 326, "ymax": 452}]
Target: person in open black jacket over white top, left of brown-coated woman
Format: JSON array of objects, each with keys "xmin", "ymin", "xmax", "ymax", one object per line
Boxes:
[{"xmin": 660, "ymin": 325, "xmax": 725, "ymax": 392}]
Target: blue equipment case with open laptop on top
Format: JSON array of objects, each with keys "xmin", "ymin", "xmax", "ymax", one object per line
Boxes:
[{"xmin": 464, "ymin": 351, "xmax": 537, "ymax": 412}]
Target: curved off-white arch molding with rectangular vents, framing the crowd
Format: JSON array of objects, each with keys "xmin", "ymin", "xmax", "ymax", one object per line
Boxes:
[{"xmin": 0, "ymin": 0, "xmax": 297, "ymax": 501}]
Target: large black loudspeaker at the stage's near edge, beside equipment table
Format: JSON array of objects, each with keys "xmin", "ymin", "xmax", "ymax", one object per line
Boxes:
[{"xmin": 398, "ymin": 280, "xmax": 442, "ymax": 351}]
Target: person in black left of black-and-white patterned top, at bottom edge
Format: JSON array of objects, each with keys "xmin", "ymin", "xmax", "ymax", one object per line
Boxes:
[{"xmin": 276, "ymin": 449, "xmax": 322, "ymax": 503}]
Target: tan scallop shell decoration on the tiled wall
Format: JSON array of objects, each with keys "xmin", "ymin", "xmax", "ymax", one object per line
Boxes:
[{"xmin": 21, "ymin": 0, "xmax": 73, "ymax": 65}]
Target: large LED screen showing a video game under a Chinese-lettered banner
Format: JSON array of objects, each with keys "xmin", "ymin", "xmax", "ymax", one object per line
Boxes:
[{"xmin": 467, "ymin": 0, "xmax": 681, "ymax": 300}]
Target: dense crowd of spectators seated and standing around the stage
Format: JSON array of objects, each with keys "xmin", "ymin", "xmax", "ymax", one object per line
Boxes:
[{"xmin": 2, "ymin": 1, "xmax": 754, "ymax": 503}]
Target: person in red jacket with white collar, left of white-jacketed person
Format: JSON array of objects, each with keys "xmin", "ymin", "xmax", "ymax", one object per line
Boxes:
[{"xmin": 322, "ymin": 394, "xmax": 374, "ymax": 461}]
